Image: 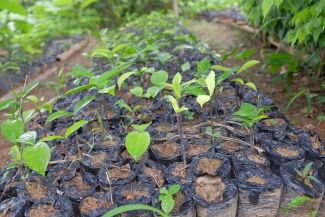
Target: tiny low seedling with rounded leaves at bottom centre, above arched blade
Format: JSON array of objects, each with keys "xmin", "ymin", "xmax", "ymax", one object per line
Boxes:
[{"xmin": 158, "ymin": 184, "xmax": 181, "ymax": 214}]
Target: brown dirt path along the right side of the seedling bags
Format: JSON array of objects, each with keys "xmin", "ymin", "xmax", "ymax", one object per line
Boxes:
[{"xmin": 188, "ymin": 20, "xmax": 325, "ymax": 140}]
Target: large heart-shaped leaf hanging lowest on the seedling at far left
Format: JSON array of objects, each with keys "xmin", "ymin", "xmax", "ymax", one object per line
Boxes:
[{"xmin": 22, "ymin": 142, "xmax": 51, "ymax": 176}]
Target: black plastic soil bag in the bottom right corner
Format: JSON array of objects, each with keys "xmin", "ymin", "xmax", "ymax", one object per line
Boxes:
[{"xmin": 278, "ymin": 160, "xmax": 324, "ymax": 217}]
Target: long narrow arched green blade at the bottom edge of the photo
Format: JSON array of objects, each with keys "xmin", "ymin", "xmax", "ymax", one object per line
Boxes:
[{"xmin": 103, "ymin": 204, "xmax": 169, "ymax": 217}]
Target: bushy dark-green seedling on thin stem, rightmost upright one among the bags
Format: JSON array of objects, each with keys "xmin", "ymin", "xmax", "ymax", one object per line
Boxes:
[{"xmin": 232, "ymin": 103, "xmax": 273, "ymax": 154}]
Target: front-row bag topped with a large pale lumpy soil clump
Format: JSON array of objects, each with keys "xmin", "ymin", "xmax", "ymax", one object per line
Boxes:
[{"xmin": 193, "ymin": 175, "xmax": 238, "ymax": 217}]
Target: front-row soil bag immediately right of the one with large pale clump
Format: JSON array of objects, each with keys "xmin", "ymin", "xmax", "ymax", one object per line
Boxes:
[{"xmin": 236, "ymin": 169, "xmax": 283, "ymax": 217}]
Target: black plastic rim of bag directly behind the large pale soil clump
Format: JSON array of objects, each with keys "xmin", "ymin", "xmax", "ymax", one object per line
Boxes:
[{"xmin": 190, "ymin": 152, "xmax": 231, "ymax": 177}]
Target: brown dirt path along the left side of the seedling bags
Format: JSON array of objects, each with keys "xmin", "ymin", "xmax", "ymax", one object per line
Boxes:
[{"xmin": 0, "ymin": 41, "xmax": 95, "ymax": 168}]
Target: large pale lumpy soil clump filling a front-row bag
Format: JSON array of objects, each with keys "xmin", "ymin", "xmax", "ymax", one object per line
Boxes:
[{"xmin": 195, "ymin": 175, "xmax": 226, "ymax": 203}]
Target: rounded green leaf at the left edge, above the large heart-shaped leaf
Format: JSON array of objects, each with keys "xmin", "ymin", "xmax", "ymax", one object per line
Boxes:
[{"xmin": 1, "ymin": 119, "xmax": 25, "ymax": 142}]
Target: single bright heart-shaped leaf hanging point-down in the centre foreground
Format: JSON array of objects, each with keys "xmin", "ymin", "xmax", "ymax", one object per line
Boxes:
[{"xmin": 125, "ymin": 131, "xmax": 150, "ymax": 162}]
